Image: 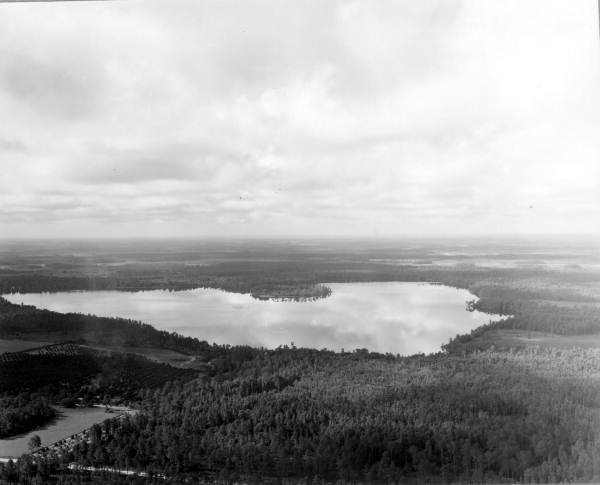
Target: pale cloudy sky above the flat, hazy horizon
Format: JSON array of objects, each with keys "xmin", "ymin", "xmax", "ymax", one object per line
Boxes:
[{"xmin": 0, "ymin": 0, "xmax": 600, "ymax": 238}]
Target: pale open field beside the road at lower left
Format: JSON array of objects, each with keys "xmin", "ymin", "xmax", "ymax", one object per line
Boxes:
[{"xmin": 0, "ymin": 408, "xmax": 115, "ymax": 458}]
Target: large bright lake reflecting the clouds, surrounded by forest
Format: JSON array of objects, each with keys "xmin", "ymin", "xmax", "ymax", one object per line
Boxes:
[{"xmin": 5, "ymin": 282, "xmax": 501, "ymax": 355}]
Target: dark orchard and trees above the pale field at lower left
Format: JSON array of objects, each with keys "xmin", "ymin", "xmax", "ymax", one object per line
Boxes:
[{"xmin": 0, "ymin": 344, "xmax": 198, "ymax": 438}]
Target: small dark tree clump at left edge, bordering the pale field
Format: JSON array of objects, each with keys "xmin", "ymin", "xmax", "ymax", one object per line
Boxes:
[{"xmin": 0, "ymin": 393, "xmax": 56, "ymax": 438}]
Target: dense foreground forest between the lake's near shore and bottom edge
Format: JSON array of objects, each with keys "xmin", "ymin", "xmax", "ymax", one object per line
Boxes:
[{"xmin": 10, "ymin": 348, "xmax": 600, "ymax": 483}]
